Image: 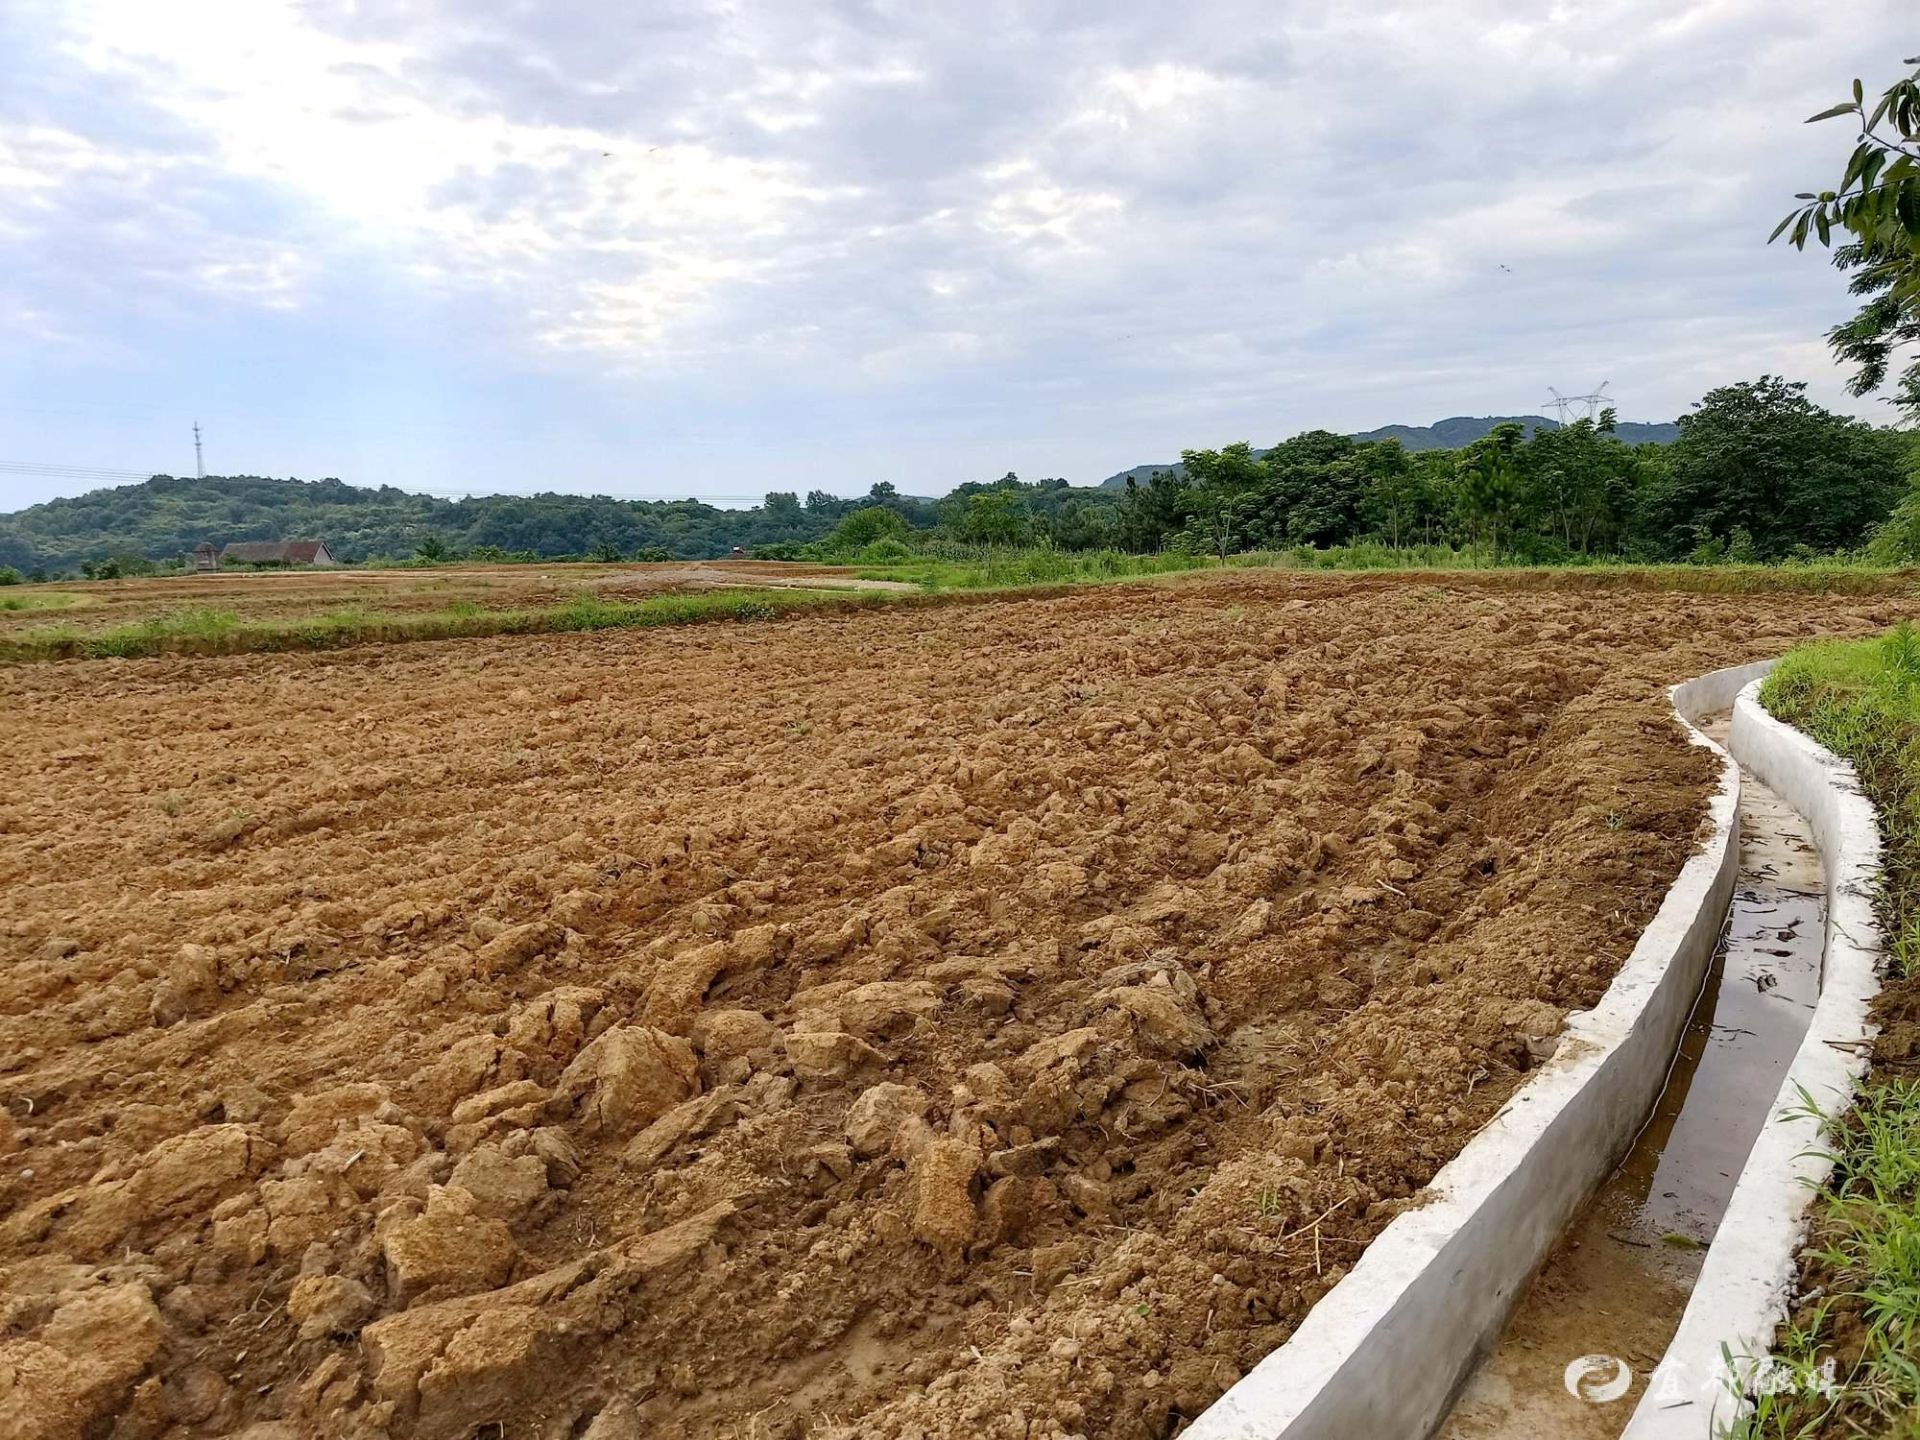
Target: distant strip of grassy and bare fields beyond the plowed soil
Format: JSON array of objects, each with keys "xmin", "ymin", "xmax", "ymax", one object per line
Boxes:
[{"xmin": 0, "ymin": 545, "xmax": 1920, "ymax": 664}]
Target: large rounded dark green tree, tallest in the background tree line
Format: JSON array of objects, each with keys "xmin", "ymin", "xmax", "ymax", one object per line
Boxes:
[{"xmin": 1651, "ymin": 374, "xmax": 1907, "ymax": 561}]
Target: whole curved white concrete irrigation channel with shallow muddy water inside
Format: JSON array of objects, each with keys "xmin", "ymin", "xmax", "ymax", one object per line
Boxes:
[{"xmin": 1190, "ymin": 662, "xmax": 1878, "ymax": 1440}]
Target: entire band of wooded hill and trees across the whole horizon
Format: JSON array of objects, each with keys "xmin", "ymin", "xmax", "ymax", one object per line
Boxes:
[{"xmin": 0, "ymin": 376, "xmax": 1920, "ymax": 576}]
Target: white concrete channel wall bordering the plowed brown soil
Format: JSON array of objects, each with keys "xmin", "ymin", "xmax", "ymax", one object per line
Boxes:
[{"xmin": 1187, "ymin": 666, "xmax": 1764, "ymax": 1440}]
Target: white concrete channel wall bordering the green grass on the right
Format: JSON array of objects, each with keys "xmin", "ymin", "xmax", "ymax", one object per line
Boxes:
[{"xmin": 1626, "ymin": 682, "xmax": 1882, "ymax": 1440}]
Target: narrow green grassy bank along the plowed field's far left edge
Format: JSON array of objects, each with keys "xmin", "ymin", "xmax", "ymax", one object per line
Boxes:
[{"xmin": 0, "ymin": 589, "xmax": 889, "ymax": 662}]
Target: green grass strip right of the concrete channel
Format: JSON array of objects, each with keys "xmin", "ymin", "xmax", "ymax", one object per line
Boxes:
[{"xmin": 1738, "ymin": 622, "xmax": 1920, "ymax": 1440}]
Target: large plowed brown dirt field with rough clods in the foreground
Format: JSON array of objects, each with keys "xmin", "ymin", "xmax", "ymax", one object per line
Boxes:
[{"xmin": 0, "ymin": 572, "xmax": 1910, "ymax": 1440}]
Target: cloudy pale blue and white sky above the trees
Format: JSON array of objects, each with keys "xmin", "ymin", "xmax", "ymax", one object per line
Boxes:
[{"xmin": 0, "ymin": 0, "xmax": 1920, "ymax": 509}]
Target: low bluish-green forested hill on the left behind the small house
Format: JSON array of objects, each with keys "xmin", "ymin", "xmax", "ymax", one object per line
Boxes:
[{"xmin": 0, "ymin": 476, "xmax": 935, "ymax": 574}]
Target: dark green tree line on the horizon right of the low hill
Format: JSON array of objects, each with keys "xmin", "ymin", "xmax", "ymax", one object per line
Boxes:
[{"xmin": 778, "ymin": 376, "xmax": 1920, "ymax": 564}]
